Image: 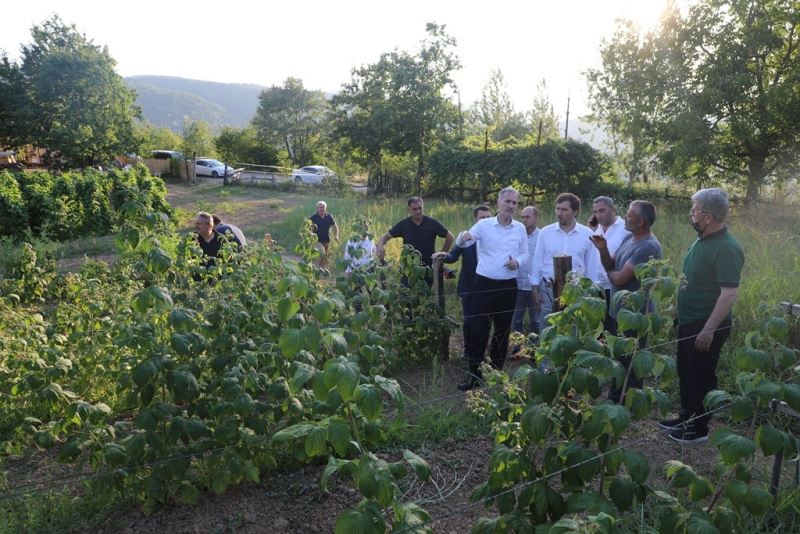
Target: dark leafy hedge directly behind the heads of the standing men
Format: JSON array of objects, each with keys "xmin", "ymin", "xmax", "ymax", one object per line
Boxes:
[{"xmin": 428, "ymin": 139, "xmax": 612, "ymax": 200}]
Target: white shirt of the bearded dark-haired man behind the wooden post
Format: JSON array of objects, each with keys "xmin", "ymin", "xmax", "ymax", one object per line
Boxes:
[{"xmin": 531, "ymin": 222, "xmax": 600, "ymax": 286}]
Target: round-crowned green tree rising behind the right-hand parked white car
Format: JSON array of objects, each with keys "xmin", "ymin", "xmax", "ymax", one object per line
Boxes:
[{"xmin": 253, "ymin": 78, "xmax": 328, "ymax": 166}]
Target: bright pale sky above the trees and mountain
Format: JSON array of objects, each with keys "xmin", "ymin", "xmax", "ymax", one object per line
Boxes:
[{"xmin": 0, "ymin": 0, "xmax": 680, "ymax": 120}]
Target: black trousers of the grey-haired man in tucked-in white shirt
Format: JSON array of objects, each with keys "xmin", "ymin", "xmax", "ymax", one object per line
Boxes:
[{"xmin": 467, "ymin": 275, "xmax": 517, "ymax": 378}]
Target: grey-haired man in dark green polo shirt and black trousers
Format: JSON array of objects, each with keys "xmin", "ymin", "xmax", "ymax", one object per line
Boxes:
[{"xmin": 659, "ymin": 188, "xmax": 744, "ymax": 443}]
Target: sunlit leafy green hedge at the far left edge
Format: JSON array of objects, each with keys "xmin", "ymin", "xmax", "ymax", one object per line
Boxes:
[{"xmin": 0, "ymin": 166, "xmax": 171, "ymax": 241}]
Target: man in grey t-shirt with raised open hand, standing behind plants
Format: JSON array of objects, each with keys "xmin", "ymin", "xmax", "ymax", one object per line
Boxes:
[{"xmin": 591, "ymin": 200, "xmax": 662, "ymax": 402}]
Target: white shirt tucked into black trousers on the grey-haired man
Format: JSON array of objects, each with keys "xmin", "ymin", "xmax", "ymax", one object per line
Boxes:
[{"xmin": 469, "ymin": 216, "xmax": 528, "ymax": 280}]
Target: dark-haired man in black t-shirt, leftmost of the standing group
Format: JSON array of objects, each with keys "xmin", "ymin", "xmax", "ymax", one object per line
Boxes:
[{"xmin": 375, "ymin": 197, "xmax": 455, "ymax": 267}]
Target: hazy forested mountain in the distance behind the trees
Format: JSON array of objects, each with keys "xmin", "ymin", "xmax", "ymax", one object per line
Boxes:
[{"xmin": 125, "ymin": 76, "xmax": 266, "ymax": 132}]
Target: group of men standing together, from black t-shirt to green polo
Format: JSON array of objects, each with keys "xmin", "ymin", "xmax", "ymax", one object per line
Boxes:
[{"xmin": 376, "ymin": 187, "xmax": 744, "ymax": 443}]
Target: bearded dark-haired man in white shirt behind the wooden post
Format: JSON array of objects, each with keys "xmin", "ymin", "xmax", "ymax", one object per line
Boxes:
[{"xmin": 531, "ymin": 193, "xmax": 599, "ymax": 328}]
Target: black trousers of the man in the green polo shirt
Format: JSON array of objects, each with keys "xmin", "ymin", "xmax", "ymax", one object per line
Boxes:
[{"xmin": 678, "ymin": 320, "xmax": 731, "ymax": 431}]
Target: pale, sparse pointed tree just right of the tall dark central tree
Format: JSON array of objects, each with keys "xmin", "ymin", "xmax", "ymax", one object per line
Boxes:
[{"xmin": 470, "ymin": 69, "xmax": 530, "ymax": 143}]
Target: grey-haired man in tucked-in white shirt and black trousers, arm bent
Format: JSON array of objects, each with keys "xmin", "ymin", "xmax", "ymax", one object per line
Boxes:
[{"xmin": 456, "ymin": 187, "xmax": 528, "ymax": 391}]
